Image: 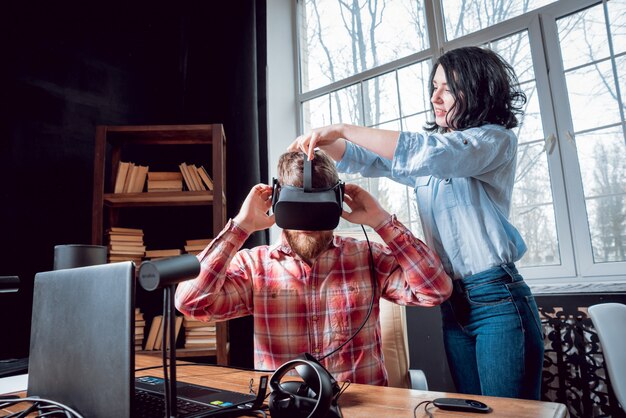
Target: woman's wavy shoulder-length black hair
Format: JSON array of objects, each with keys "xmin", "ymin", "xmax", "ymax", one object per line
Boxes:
[{"xmin": 424, "ymin": 46, "xmax": 526, "ymax": 132}]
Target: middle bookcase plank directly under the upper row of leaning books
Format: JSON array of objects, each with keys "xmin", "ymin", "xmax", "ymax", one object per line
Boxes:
[{"xmin": 104, "ymin": 191, "xmax": 213, "ymax": 208}]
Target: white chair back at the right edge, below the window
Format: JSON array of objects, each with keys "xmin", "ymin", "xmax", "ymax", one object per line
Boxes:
[{"xmin": 589, "ymin": 303, "xmax": 626, "ymax": 411}]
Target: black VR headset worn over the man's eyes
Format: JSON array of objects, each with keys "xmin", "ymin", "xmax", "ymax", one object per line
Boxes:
[{"xmin": 272, "ymin": 156, "xmax": 345, "ymax": 231}]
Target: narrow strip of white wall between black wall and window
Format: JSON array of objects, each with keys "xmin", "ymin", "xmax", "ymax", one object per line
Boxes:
[{"xmin": 267, "ymin": 0, "xmax": 298, "ymax": 242}]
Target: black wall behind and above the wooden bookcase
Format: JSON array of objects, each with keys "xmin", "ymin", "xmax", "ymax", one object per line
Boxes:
[{"xmin": 0, "ymin": 0, "xmax": 267, "ymax": 365}]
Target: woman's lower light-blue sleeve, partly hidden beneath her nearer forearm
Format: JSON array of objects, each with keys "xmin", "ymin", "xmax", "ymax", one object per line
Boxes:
[{"xmin": 337, "ymin": 141, "xmax": 415, "ymax": 187}]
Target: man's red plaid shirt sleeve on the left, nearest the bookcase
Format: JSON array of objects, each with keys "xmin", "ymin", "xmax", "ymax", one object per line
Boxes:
[{"xmin": 175, "ymin": 220, "xmax": 252, "ymax": 321}]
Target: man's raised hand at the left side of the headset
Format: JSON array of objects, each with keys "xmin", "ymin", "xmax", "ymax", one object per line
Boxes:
[{"xmin": 233, "ymin": 184, "xmax": 274, "ymax": 234}]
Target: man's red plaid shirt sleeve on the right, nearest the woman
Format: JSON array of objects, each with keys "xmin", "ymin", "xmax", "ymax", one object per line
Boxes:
[{"xmin": 376, "ymin": 215, "xmax": 452, "ymax": 306}]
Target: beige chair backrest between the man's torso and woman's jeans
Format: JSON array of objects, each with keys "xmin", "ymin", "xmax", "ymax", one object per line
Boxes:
[{"xmin": 380, "ymin": 299, "xmax": 411, "ymax": 388}]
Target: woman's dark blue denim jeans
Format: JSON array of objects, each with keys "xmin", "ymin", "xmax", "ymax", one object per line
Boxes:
[{"xmin": 441, "ymin": 263, "xmax": 543, "ymax": 400}]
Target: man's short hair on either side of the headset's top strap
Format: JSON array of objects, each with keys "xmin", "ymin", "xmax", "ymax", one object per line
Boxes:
[{"xmin": 278, "ymin": 150, "xmax": 339, "ymax": 189}]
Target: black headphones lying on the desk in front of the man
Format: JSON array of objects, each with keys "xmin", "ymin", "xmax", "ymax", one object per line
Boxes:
[{"xmin": 269, "ymin": 353, "xmax": 342, "ymax": 418}]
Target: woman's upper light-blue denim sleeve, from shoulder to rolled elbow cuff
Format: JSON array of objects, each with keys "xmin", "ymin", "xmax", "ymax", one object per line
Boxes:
[{"xmin": 391, "ymin": 125, "xmax": 517, "ymax": 179}]
